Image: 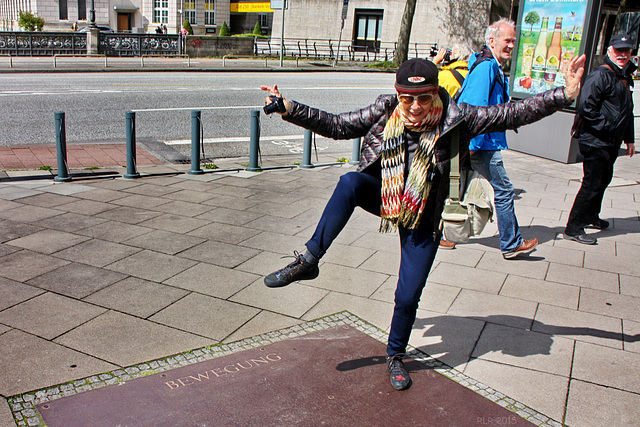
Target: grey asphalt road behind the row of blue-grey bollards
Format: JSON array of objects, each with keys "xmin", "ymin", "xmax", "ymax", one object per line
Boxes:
[{"xmin": 0, "ymin": 72, "xmax": 393, "ymax": 157}]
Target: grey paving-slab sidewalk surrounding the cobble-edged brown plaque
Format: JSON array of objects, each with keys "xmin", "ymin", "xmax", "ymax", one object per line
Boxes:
[{"xmin": 0, "ymin": 151, "xmax": 640, "ymax": 426}]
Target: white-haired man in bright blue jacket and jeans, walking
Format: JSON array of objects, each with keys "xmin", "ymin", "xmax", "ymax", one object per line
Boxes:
[{"xmin": 458, "ymin": 18, "xmax": 538, "ymax": 259}]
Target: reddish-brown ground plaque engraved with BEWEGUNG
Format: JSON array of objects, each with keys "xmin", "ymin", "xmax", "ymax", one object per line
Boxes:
[{"xmin": 37, "ymin": 326, "xmax": 531, "ymax": 427}]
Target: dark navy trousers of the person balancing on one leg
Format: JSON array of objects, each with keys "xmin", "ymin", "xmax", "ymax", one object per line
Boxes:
[{"xmin": 306, "ymin": 172, "xmax": 439, "ymax": 356}]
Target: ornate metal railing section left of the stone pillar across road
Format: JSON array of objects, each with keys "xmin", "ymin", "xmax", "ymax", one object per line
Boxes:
[{"xmin": 0, "ymin": 31, "xmax": 87, "ymax": 56}]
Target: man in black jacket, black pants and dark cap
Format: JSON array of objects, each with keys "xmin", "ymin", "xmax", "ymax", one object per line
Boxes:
[{"xmin": 564, "ymin": 34, "xmax": 636, "ymax": 245}]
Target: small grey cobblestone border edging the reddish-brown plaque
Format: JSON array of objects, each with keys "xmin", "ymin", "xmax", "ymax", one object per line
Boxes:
[{"xmin": 7, "ymin": 311, "xmax": 562, "ymax": 427}]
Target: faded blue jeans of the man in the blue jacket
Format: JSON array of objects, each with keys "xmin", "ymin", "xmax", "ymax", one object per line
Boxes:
[{"xmin": 471, "ymin": 150, "xmax": 523, "ymax": 254}]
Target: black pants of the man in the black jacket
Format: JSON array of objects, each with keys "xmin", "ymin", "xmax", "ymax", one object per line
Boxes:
[{"xmin": 565, "ymin": 144, "xmax": 619, "ymax": 234}]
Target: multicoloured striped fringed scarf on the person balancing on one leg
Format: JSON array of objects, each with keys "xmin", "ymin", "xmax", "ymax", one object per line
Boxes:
[{"xmin": 380, "ymin": 96, "xmax": 442, "ymax": 233}]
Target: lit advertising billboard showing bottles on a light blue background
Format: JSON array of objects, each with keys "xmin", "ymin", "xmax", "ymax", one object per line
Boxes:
[{"xmin": 510, "ymin": 0, "xmax": 594, "ymax": 98}]
